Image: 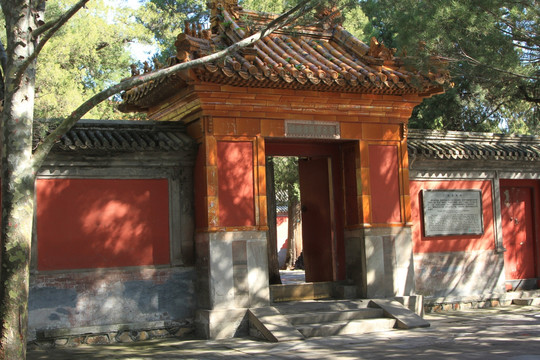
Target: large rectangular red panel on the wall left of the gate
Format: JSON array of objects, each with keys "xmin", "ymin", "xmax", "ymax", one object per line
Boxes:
[{"xmin": 36, "ymin": 179, "xmax": 170, "ymax": 270}]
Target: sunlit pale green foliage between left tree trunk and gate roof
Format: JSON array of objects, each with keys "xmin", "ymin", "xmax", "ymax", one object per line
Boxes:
[{"xmin": 34, "ymin": 0, "xmax": 150, "ymax": 119}]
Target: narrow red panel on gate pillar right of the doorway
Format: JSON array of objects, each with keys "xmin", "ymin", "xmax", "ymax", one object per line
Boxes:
[{"xmin": 369, "ymin": 145, "xmax": 401, "ymax": 223}]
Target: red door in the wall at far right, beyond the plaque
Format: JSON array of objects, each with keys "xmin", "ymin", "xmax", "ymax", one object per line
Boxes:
[{"xmin": 501, "ymin": 186, "xmax": 536, "ymax": 280}]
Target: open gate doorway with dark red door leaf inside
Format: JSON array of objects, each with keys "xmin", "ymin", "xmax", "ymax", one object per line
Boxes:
[{"xmin": 266, "ymin": 142, "xmax": 345, "ymax": 287}]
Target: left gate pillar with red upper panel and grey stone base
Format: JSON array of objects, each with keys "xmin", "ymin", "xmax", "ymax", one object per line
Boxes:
[{"xmin": 195, "ymin": 132, "xmax": 270, "ymax": 339}]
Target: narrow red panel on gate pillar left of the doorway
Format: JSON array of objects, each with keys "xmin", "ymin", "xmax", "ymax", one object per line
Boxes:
[{"xmin": 217, "ymin": 141, "xmax": 255, "ymax": 226}]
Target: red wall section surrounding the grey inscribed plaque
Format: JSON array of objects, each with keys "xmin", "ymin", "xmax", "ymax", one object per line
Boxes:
[{"xmin": 410, "ymin": 180, "xmax": 495, "ymax": 253}]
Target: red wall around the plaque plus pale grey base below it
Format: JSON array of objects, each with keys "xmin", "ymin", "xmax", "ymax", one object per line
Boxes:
[{"xmin": 410, "ymin": 180, "xmax": 505, "ymax": 297}]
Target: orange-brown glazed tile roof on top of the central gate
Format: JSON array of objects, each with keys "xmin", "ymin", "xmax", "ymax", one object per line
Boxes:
[{"xmin": 121, "ymin": 0, "xmax": 449, "ymax": 111}]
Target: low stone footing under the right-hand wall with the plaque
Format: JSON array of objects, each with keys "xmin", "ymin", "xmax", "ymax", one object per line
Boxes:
[{"xmin": 424, "ymin": 290, "xmax": 540, "ymax": 314}]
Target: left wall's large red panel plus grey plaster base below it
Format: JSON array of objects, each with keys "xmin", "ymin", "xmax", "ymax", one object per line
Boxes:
[{"xmin": 29, "ymin": 179, "xmax": 196, "ymax": 336}]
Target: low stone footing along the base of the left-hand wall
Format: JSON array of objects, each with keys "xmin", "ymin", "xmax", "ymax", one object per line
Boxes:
[{"xmin": 28, "ymin": 321, "xmax": 195, "ymax": 349}]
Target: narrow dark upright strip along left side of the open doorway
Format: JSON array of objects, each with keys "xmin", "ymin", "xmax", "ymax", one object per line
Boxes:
[{"xmin": 266, "ymin": 157, "xmax": 281, "ymax": 285}]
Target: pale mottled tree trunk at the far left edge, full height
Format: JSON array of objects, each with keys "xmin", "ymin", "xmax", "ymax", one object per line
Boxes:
[{"xmin": 0, "ymin": 1, "xmax": 36, "ymax": 360}]
